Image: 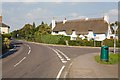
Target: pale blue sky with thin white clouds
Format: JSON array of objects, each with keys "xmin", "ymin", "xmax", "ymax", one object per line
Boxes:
[{"xmin": 0, "ymin": 0, "xmax": 118, "ymax": 31}]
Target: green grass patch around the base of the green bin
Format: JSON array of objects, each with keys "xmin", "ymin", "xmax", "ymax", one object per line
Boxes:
[{"xmin": 95, "ymin": 53, "xmax": 120, "ymax": 64}]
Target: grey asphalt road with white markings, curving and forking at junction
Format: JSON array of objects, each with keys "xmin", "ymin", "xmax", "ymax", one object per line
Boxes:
[{"xmin": 2, "ymin": 41, "xmax": 100, "ymax": 79}]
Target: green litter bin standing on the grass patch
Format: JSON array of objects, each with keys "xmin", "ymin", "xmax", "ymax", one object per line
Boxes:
[{"xmin": 100, "ymin": 46, "xmax": 109, "ymax": 62}]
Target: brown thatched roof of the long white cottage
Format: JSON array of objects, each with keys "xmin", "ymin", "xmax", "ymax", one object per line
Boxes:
[{"xmin": 53, "ymin": 18, "xmax": 108, "ymax": 34}]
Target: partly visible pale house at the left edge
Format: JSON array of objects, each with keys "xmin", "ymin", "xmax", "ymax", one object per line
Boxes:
[{"xmin": 0, "ymin": 16, "xmax": 10, "ymax": 34}]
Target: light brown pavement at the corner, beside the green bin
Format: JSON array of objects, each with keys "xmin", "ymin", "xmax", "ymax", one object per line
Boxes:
[{"xmin": 68, "ymin": 53, "xmax": 118, "ymax": 78}]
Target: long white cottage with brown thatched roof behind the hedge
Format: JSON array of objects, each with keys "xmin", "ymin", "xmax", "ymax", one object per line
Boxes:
[{"xmin": 51, "ymin": 16, "xmax": 111, "ymax": 41}]
